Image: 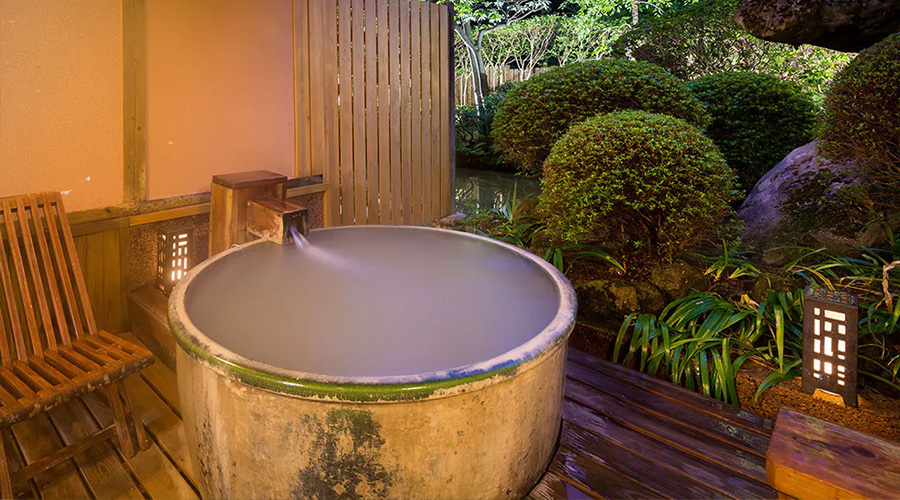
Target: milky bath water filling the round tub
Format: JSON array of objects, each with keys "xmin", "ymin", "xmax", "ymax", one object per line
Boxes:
[{"xmin": 185, "ymin": 227, "xmax": 559, "ymax": 377}]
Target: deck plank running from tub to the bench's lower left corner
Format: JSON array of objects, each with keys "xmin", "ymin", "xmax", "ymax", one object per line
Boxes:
[{"xmin": 563, "ymin": 400, "xmax": 775, "ymax": 498}]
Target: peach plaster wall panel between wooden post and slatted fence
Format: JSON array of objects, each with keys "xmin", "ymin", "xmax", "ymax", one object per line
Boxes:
[{"xmin": 144, "ymin": 0, "xmax": 296, "ymax": 199}]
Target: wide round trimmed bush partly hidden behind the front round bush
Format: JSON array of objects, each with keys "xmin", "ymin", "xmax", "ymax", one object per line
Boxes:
[{"xmin": 493, "ymin": 59, "xmax": 709, "ymax": 173}]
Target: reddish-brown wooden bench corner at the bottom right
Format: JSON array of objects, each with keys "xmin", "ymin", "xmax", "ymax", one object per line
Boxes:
[{"xmin": 766, "ymin": 408, "xmax": 900, "ymax": 499}]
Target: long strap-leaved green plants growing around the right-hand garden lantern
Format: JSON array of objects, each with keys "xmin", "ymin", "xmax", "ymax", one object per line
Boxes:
[{"xmin": 613, "ymin": 232, "xmax": 900, "ymax": 404}]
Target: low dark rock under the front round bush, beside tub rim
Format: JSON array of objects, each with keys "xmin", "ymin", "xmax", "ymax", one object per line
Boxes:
[{"xmin": 575, "ymin": 278, "xmax": 666, "ymax": 324}]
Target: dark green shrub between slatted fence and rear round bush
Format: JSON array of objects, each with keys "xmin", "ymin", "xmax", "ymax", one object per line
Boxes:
[{"xmin": 456, "ymin": 82, "xmax": 519, "ymax": 171}]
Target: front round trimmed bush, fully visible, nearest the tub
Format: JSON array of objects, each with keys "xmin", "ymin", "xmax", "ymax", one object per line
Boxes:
[{"xmin": 541, "ymin": 111, "xmax": 733, "ymax": 257}]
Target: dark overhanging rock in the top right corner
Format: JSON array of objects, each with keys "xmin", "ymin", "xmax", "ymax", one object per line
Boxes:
[{"xmin": 735, "ymin": 0, "xmax": 900, "ymax": 52}]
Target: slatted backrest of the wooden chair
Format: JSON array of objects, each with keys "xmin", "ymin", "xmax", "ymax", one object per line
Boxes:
[{"xmin": 0, "ymin": 193, "xmax": 97, "ymax": 365}]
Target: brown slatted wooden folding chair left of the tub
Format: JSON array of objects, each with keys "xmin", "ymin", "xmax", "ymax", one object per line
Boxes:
[{"xmin": 0, "ymin": 193, "xmax": 153, "ymax": 498}]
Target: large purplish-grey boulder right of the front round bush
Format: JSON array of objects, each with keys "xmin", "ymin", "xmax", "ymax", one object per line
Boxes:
[{"xmin": 737, "ymin": 141, "xmax": 882, "ymax": 258}]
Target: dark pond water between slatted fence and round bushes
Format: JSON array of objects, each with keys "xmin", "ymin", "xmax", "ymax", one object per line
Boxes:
[{"xmin": 456, "ymin": 168, "xmax": 541, "ymax": 215}]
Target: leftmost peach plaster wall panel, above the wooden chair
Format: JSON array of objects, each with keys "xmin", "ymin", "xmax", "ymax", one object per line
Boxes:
[{"xmin": 0, "ymin": 0, "xmax": 123, "ymax": 211}]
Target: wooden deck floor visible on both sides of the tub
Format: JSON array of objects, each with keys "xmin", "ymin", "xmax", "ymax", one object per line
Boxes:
[{"xmin": 7, "ymin": 334, "xmax": 775, "ymax": 500}]
